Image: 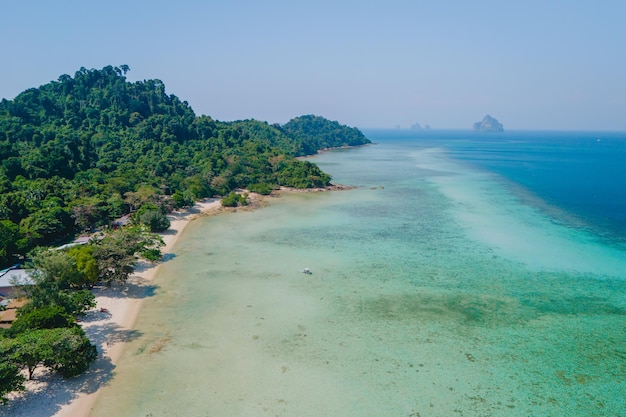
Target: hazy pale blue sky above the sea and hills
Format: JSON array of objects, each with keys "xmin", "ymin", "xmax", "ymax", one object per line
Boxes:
[{"xmin": 0, "ymin": 0, "xmax": 626, "ymax": 130}]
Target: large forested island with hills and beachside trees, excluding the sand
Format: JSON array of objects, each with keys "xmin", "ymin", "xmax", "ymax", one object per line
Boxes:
[{"xmin": 0, "ymin": 65, "xmax": 370, "ymax": 407}]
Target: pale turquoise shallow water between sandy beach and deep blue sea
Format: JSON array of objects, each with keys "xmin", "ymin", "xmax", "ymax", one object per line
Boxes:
[{"xmin": 93, "ymin": 133, "xmax": 626, "ymax": 417}]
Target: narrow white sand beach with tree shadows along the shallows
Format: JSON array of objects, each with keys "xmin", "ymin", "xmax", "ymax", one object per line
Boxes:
[{"xmin": 0, "ymin": 198, "xmax": 221, "ymax": 417}]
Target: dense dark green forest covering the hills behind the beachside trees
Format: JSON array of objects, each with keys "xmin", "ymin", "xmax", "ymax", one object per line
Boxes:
[{"xmin": 0, "ymin": 65, "xmax": 369, "ymax": 266}]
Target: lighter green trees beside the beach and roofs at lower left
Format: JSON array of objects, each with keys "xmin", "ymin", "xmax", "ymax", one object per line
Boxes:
[{"xmin": 0, "ymin": 225, "xmax": 164, "ymax": 404}]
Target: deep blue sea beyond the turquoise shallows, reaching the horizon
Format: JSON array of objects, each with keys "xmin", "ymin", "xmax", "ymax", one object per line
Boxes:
[{"xmin": 366, "ymin": 130, "xmax": 626, "ymax": 240}]
